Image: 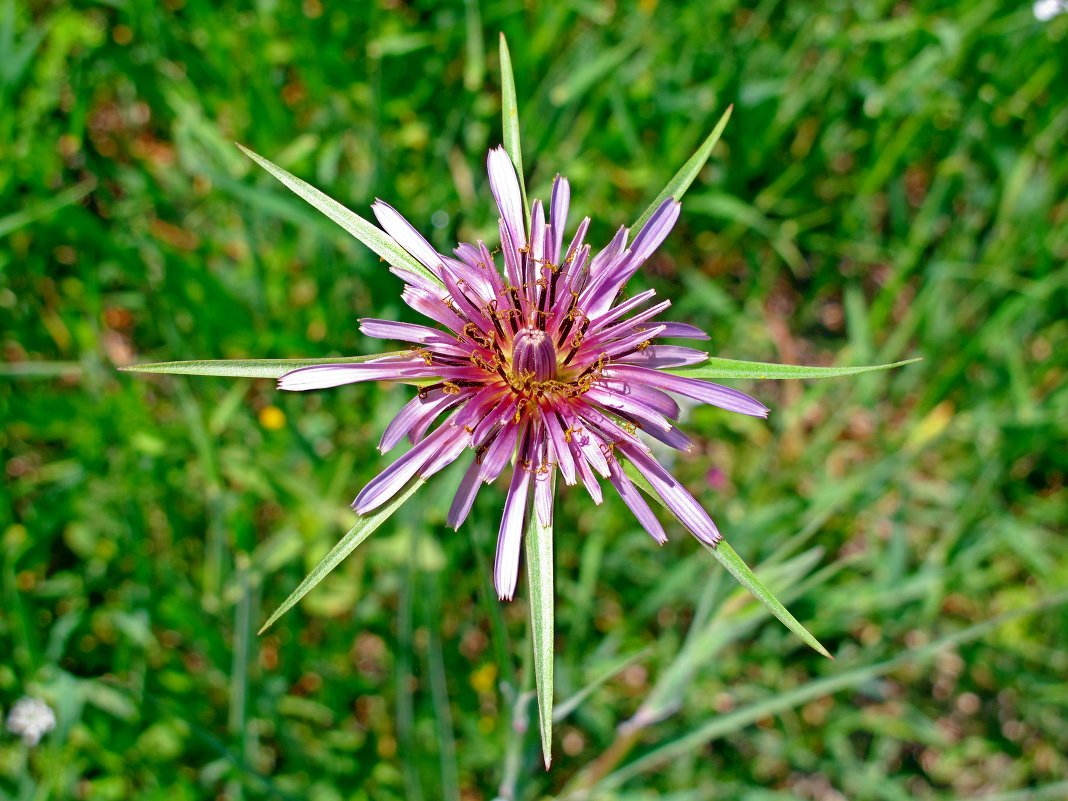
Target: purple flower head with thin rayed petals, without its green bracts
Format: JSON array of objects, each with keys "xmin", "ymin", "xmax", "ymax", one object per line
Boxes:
[{"xmin": 279, "ymin": 147, "xmax": 768, "ymax": 600}]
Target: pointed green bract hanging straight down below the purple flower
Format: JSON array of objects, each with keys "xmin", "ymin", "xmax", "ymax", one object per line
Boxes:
[{"xmin": 516, "ymin": 476, "xmax": 555, "ymax": 770}]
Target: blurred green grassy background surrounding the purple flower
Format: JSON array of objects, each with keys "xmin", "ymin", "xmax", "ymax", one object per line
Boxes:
[{"xmin": 0, "ymin": 0, "xmax": 1068, "ymax": 801}]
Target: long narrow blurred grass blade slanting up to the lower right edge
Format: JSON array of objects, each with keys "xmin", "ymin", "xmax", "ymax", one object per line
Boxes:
[{"xmin": 593, "ymin": 593, "xmax": 1068, "ymax": 797}]
